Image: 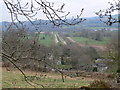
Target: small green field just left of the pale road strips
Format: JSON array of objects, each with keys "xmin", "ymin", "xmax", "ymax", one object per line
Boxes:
[{"xmin": 39, "ymin": 34, "xmax": 54, "ymax": 46}]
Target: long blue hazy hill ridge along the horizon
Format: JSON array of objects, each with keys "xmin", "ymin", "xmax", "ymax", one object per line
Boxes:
[{"xmin": 0, "ymin": 15, "xmax": 118, "ymax": 32}]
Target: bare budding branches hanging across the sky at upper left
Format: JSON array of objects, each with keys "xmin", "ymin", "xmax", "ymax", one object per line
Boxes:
[{"xmin": 3, "ymin": 0, "xmax": 85, "ymax": 27}]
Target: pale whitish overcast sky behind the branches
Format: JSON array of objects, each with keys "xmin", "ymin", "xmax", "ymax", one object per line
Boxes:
[{"xmin": 0, "ymin": 0, "xmax": 117, "ymax": 22}]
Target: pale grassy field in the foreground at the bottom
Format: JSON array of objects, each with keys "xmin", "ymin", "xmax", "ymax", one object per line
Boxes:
[{"xmin": 2, "ymin": 69, "xmax": 93, "ymax": 88}]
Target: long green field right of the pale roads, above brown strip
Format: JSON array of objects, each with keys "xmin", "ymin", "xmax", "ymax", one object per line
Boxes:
[{"xmin": 71, "ymin": 37, "xmax": 109, "ymax": 45}]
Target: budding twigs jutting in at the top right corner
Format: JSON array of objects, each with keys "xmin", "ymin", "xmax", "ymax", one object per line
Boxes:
[{"xmin": 96, "ymin": 0, "xmax": 120, "ymax": 26}]
